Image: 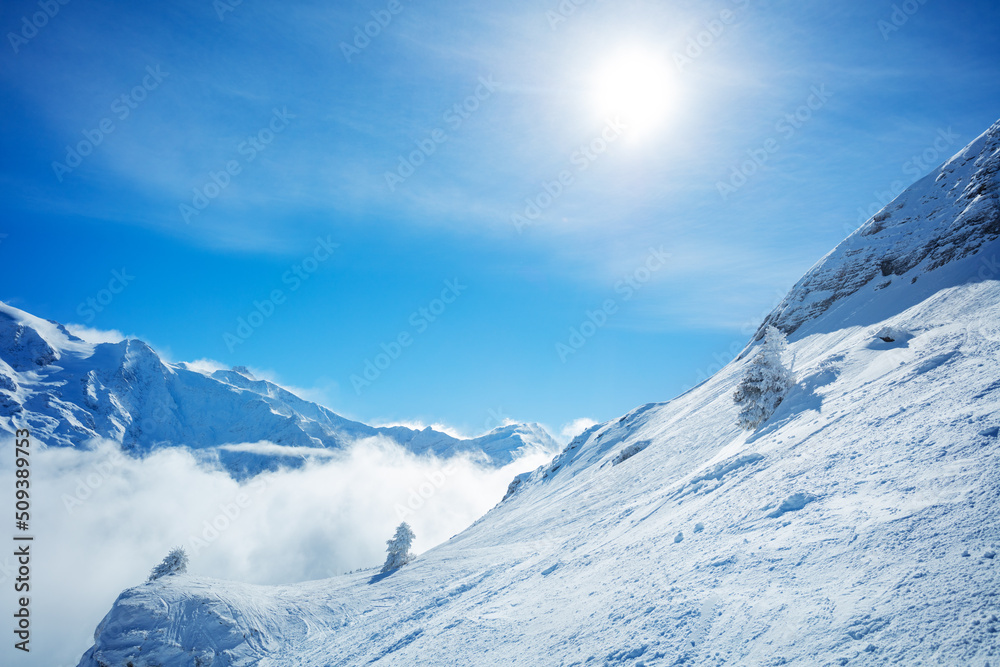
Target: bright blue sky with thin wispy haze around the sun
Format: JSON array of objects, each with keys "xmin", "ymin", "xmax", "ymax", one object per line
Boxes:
[{"xmin": 0, "ymin": 0, "xmax": 1000, "ymax": 432}]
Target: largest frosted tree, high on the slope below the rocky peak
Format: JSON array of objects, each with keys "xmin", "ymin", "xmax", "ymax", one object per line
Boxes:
[{"xmin": 733, "ymin": 326, "xmax": 793, "ymax": 431}]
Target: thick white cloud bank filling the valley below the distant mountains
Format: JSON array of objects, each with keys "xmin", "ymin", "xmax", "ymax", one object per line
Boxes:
[{"xmin": 0, "ymin": 438, "xmax": 548, "ymax": 665}]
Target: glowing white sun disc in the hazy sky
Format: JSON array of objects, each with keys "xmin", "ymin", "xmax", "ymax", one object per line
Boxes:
[{"xmin": 591, "ymin": 49, "xmax": 676, "ymax": 136}]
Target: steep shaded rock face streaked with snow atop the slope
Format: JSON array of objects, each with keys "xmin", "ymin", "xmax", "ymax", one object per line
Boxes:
[{"xmin": 756, "ymin": 122, "xmax": 1000, "ymax": 339}]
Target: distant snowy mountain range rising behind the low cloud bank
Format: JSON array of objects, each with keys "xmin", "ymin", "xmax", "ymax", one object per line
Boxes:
[{"xmin": 0, "ymin": 303, "xmax": 558, "ymax": 476}]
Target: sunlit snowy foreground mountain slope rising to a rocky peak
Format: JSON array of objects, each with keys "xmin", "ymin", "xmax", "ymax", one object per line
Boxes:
[{"xmin": 80, "ymin": 123, "xmax": 1000, "ymax": 667}]
